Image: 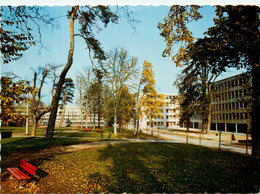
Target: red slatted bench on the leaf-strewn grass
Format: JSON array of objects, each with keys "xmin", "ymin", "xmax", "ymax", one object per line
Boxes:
[{"xmin": 7, "ymin": 160, "xmax": 37, "ymax": 189}]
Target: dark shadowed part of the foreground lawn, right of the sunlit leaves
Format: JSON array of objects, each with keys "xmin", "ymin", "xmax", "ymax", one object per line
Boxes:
[{"xmin": 95, "ymin": 143, "xmax": 259, "ymax": 193}]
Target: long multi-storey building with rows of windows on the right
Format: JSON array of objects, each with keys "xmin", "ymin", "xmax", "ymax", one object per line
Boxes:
[{"xmin": 211, "ymin": 74, "xmax": 251, "ymax": 133}]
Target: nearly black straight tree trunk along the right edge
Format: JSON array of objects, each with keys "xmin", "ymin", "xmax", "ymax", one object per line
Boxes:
[{"xmin": 251, "ymin": 63, "xmax": 260, "ymax": 171}]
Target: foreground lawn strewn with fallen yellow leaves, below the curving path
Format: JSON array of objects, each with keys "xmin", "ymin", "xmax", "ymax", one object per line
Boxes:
[{"xmin": 36, "ymin": 143, "xmax": 259, "ymax": 193}]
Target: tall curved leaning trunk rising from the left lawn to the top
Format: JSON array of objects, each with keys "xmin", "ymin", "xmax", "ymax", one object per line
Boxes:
[{"xmin": 45, "ymin": 6, "xmax": 78, "ymax": 139}]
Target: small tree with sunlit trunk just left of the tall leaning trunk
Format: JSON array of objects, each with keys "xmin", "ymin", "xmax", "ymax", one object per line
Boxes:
[{"xmin": 31, "ymin": 65, "xmax": 59, "ymax": 136}]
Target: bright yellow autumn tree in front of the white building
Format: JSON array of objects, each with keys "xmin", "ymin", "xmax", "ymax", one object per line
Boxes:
[{"xmin": 139, "ymin": 61, "xmax": 165, "ymax": 134}]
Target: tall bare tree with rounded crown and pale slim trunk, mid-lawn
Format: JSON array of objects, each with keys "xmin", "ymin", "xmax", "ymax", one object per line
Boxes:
[{"xmin": 104, "ymin": 49, "xmax": 137, "ymax": 135}]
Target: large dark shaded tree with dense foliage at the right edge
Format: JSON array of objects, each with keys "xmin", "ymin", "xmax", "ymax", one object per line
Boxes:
[{"xmin": 206, "ymin": 6, "xmax": 260, "ymax": 171}]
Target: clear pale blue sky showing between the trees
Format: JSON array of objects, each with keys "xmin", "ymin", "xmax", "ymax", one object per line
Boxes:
[{"xmin": 1, "ymin": 6, "xmax": 251, "ymax": 103}]
